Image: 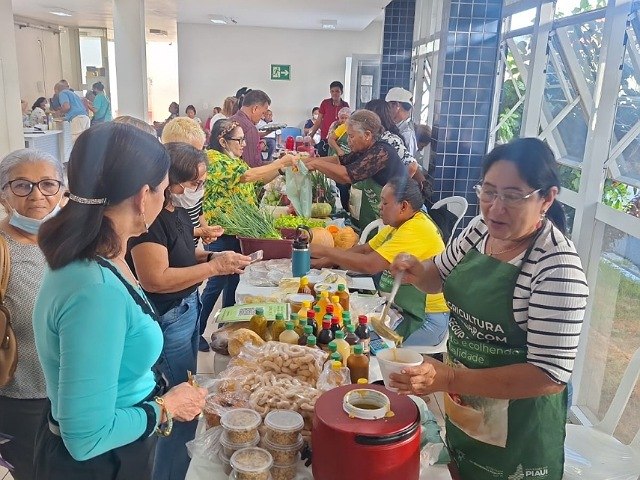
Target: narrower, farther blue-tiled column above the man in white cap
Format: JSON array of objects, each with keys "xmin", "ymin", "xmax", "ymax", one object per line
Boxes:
[{"xmin": 380, "ymin": 0, "xmax": 416, "ymax": 98}]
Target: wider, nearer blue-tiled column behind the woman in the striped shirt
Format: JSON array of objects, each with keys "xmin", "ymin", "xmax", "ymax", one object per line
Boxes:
[{"xmin": 433, "ymin": 0, "xmax": 502, "ymax": 224}]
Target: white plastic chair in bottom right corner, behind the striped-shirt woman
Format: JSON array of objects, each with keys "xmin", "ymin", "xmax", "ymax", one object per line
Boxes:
[{"xmin": 563, "ymin": 349, "xmax": 640, "ymax": 480}]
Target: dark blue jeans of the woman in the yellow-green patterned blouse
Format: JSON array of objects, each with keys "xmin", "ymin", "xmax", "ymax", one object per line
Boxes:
[{"xmin": 200, "ymin": 235, "xmax": 240, "ymax": 334}]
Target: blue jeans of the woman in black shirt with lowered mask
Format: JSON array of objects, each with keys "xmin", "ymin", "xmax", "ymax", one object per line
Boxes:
[{"xmin": 153, "ymin": 291, "xmax": 200, "ymax": 480}]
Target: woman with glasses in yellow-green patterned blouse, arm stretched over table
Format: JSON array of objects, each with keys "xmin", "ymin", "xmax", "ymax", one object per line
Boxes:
[{"xmin": 200, "ymin": 119, "xmax": 297, "ymax": 323}]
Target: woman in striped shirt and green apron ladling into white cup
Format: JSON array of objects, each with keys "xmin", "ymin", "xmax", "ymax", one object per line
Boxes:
[{"xmin": 391, "ymin": 138, "xmax": 589, "ymax": 480}]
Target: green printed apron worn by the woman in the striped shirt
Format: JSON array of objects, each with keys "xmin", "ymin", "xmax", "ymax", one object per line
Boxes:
[{"xmin": 444, "ymin": 248, "xmax": 567, "ymax": 480}]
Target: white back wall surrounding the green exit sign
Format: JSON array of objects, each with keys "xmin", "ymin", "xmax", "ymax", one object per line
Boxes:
[{"xmin": 178, "ymin": 22, "xmax": 382, "ymax": 125}]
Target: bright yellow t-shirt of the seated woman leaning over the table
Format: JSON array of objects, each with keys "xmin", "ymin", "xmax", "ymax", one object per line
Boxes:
[{"xmin": 368, "ymin": 212, "xmax": 449, "ymax": 313}]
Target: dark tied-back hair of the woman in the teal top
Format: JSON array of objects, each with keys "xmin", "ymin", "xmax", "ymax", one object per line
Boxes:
[{"xmin": 38, "ymin": 122, "xmax": 169, "ymax": 270}]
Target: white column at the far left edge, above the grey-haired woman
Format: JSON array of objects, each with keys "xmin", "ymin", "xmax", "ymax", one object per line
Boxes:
[{"xmin": 0, "ymin": 0, "xmax": 24, "ymax": 157}]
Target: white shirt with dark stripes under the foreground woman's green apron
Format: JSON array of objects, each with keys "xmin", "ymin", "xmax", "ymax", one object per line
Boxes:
[{"xmin": 434, "ymin": 216, "xmax": 589, "ymax": 383}]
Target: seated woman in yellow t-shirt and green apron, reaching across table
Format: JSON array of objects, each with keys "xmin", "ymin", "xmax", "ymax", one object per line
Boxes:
[{"xmin": 311, "ymin": 177, "xmax": 449, "ymax": 345}]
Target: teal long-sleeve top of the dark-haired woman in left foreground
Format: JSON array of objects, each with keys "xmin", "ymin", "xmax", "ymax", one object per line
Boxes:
[{"xmin": 33, "ymin": 261, "xmax": 163, "ymax": 460}]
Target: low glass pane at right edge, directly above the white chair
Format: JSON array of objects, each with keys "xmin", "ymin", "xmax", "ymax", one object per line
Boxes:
[{"xmin": 578, "ymin": 226, "xmax": 640, "ymax": 443}]
